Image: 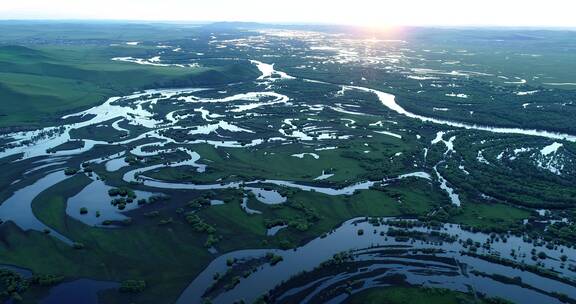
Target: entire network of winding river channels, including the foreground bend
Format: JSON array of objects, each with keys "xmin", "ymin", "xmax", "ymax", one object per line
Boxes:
[{"xmin": 0, "ymin": 61, "xmax": 576, "ymax": 303}]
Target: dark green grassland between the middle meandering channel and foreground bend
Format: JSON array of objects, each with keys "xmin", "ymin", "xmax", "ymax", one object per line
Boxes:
[{"xmin": 0, "ymin": 169, "xmax": 441, "ymax": 303}]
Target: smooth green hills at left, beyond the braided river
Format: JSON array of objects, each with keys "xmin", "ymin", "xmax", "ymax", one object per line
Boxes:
[{"xmin": 0, "ymin": 45, "xmax": 258, "ymax": 127}]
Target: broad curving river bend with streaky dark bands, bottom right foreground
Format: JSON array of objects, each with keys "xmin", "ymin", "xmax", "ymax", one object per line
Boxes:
[{"xmin": 178, "ymin": 219, "xmax": 576, "ymax": 303}]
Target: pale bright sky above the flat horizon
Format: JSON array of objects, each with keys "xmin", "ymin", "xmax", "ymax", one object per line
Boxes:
[{"xmin": 0, "ymin": 0, "xmax": 576, "ymax": 27}]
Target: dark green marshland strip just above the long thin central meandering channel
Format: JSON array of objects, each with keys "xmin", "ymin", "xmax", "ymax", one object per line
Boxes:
[{"xmin": 148, "ymin": 135, "xmax": 415, "ymax": 184}]
